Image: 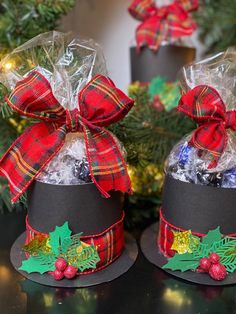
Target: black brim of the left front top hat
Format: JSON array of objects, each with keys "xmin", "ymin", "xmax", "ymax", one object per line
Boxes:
[{"xmin": 10, "ymin": 232, "xmax": 138, "ymax": 288}]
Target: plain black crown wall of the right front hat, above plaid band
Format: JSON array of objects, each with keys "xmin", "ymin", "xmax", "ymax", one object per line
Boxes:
[{"xmin": 162, "ymin": 175, "xmax": 236, "ymax": 234}]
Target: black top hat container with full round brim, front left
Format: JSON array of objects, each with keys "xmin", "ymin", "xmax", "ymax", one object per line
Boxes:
[{"xmin": 11, "ymin": 181, "xmax": 138, "ymax": 288}]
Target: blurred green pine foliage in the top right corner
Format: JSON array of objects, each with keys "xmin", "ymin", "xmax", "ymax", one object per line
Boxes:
[{"xmin": 195, "ymin": 0, "xmax": 236, "ymax": 53}]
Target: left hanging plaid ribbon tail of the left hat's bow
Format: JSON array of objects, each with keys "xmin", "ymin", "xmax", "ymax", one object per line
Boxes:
[{"xmin": 0, "ymin": 122, "xmax": 65, "ymax": 203}]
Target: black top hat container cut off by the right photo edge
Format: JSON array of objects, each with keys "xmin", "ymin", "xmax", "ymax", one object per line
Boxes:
[{"xmin": 141, "ymin": 175, "xmax": 236, "ymax": 286}]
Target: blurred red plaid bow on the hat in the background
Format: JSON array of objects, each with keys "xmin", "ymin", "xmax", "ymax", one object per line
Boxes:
[{"xmin": 128, "ymin": 0, "xmax": 198, "ymax": 50}]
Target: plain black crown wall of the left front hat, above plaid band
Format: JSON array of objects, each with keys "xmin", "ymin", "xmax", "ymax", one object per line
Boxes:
[{"xmin": 28, "ymin": 181, "xmax": 123, "ymax": 235}]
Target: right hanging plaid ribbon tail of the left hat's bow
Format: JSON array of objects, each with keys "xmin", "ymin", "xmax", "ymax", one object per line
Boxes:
[{"xmin": 83, "ymin": 125, "xmax": 132, "ymax": 198}]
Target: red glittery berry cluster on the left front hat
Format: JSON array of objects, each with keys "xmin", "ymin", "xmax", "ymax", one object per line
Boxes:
[{"xmin": 51, "ymin": 258, "xmax": 78, "ymax": 280}]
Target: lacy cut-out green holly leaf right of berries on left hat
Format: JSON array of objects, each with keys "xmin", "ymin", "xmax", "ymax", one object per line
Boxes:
[{"xmin": 65, "ymin": 233, "xmax": 100, "ymax": 271}]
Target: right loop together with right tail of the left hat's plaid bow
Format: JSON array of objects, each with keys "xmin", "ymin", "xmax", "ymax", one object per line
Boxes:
[{"xmin": 79, "ymin": 75, "xmax": 134, "ymax": 197}]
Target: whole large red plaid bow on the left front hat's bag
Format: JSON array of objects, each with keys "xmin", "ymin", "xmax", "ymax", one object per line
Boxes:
[{"xmin": 0, "ymin": 72, "xmax": 133, "ymax": 202}]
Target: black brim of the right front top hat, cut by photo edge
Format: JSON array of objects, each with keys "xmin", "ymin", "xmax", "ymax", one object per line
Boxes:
[{"xmin": 140, "ymin": 223, "xmax": 236, "ymax": 286}]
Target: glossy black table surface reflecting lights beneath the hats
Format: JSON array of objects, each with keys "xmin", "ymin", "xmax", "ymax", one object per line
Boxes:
[{"xmin": 0, "ymin": 213, "xmax": 236, "ymax": 314}]
